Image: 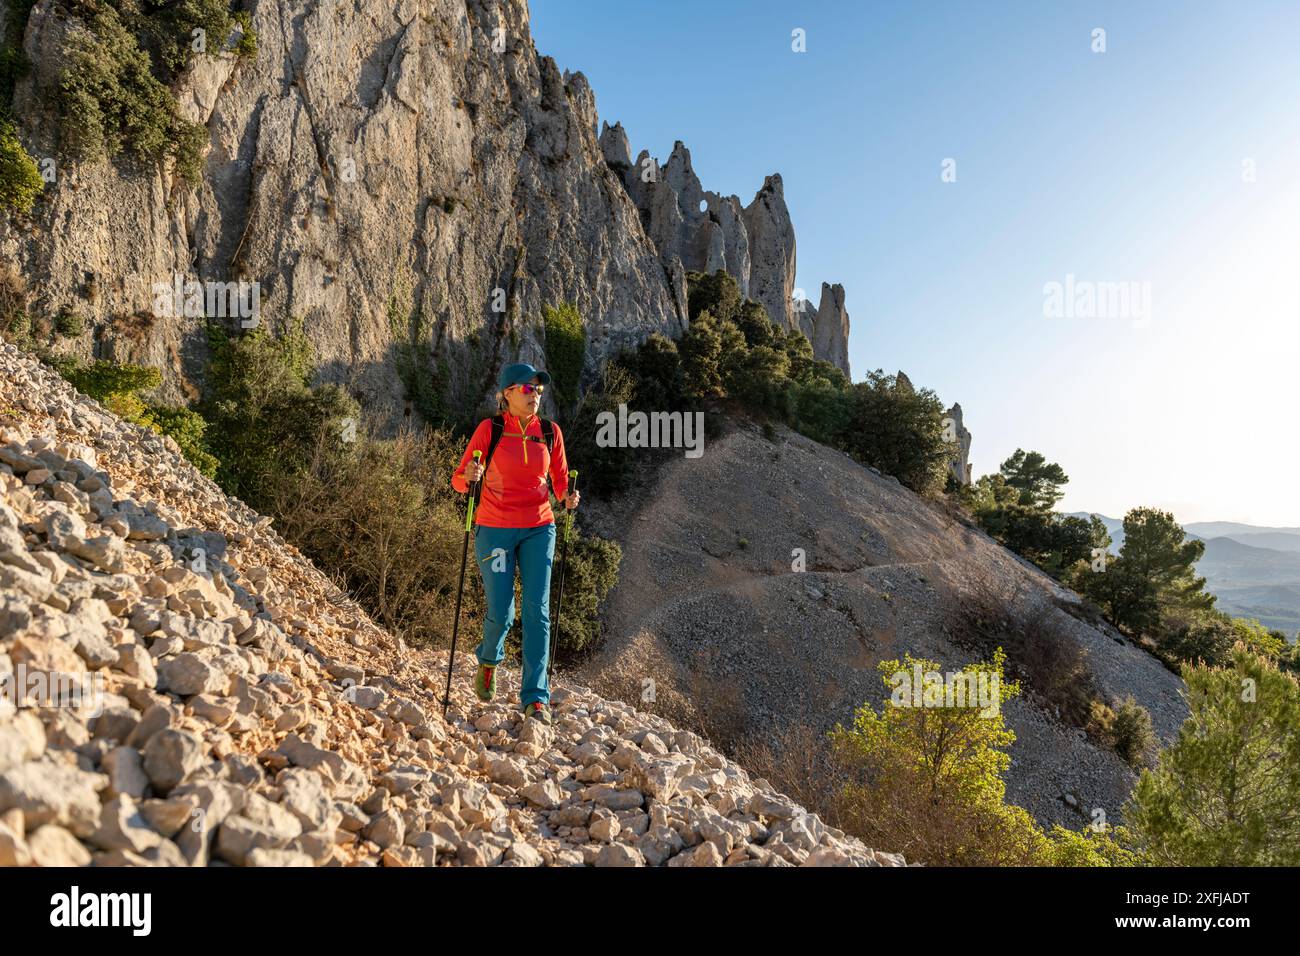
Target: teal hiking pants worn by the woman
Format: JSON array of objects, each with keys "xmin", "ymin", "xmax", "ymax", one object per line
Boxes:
[{"xmin": 475, "ymin": 523, "xmax": 555, "ymax": 705}]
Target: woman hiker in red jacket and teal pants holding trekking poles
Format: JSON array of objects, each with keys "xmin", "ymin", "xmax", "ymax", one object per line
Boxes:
[{"xmin": 451, "ymin": 363, "xmax": 580, "ymax": 723}]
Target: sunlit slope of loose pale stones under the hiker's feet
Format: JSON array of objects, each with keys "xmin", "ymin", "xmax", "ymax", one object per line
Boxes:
[{"xmin": 0, "ymin": 343, "xmax": 904, "ymax": 868}]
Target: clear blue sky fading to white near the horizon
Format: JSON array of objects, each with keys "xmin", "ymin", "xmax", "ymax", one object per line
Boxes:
[{"xmin": 532, "ymin": 0, "xmax": 1300, "ymax": 525}]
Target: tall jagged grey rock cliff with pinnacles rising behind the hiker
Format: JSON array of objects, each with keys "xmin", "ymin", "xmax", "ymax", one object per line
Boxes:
[{"xmin": 0, "ymin": 0, "xmax": 848, "ymax": 423}]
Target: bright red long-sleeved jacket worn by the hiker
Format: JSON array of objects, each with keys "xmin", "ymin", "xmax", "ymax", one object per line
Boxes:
[{"xmin": 451, "ymin": 412, "xmax": 568, "ymax": 528}]
